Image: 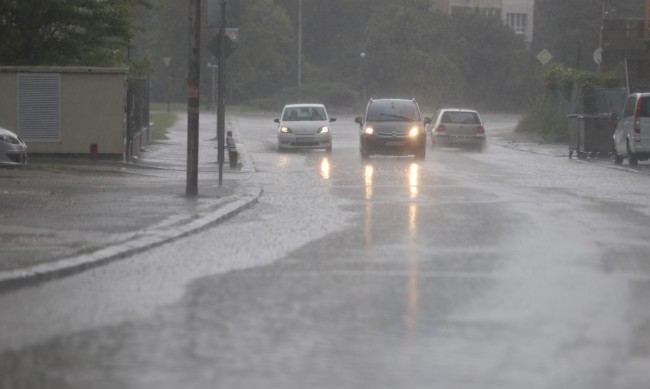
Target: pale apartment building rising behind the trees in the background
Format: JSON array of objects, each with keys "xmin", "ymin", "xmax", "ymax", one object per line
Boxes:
[{"xmin": 431, "ymin": 0, "xmax": 535, "ymax": 44}]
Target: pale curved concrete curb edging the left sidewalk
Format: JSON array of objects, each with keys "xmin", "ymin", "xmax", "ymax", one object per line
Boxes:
[{"xmin": 0, "ymin": 183, "xmax": 263, "ymax": 290}]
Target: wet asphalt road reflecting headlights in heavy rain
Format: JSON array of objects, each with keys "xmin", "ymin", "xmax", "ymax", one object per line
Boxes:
[{"xmin": 0, "ymin": 115, "xmax": 650, "ymax": 389}]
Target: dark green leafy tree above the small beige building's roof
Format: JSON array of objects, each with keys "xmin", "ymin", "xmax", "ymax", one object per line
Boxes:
[{"xmin": 0, "ymin": 0, "xmax": 148, "ymax": 66}]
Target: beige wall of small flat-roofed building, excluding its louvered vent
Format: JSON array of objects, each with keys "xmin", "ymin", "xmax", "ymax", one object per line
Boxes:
[{"xmin": 0, "ymin": 67, "xmax": 128, "ymax": 159}]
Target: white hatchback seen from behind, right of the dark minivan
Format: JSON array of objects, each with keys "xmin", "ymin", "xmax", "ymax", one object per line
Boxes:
[{"xmin": 431, "ymin": 108, "xmax": 486, "ymax": 151}]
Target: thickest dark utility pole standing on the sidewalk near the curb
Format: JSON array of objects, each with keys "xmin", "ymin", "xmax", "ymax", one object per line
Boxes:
[{"xmin": 185, "ymin": 0, "xmax": 201, "ymax": 197}]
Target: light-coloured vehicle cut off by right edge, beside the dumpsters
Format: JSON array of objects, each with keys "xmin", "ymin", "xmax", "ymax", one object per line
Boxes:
[{"xmin": 614, "ymin": 93, "xmax": 650, "ymax": 166}]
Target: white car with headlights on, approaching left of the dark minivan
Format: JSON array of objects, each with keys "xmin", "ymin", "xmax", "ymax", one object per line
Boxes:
[{"xmin": 274, "ymin": 104, "xmax": 336, "ymax": 152}]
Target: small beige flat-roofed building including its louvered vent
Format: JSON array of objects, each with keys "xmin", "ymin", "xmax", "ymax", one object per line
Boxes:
[{"xmin": 0, "ymin": 66, "xmax": 128, "ymax": 160}]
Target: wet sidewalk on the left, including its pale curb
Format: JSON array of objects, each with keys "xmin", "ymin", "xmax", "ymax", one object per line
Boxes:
[{"xmin": 0, "ymin": 114, "xmax": 261, "ymax": 288}]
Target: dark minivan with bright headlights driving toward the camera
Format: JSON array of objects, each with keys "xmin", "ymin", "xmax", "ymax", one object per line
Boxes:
[{"xmin": 355, "ymin": 99, "xmax": 431, "ymax": 159}]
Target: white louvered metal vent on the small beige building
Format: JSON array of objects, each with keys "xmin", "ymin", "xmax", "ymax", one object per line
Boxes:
[{"xmin": 18, "ymin": 74, "xmax": 61, "ymax": 141}]
